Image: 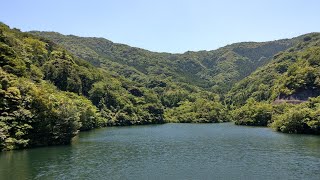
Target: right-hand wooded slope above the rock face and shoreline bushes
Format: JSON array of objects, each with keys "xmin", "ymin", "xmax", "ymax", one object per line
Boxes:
[{"xmin": 227, "ymin": 33, "xmax": 320, "ymax": 106}]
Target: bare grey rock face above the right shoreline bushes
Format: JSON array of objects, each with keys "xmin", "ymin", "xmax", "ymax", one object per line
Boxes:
[{"xmin": 273, "ymin": 89, "xmax": 320, "ymax": 104}]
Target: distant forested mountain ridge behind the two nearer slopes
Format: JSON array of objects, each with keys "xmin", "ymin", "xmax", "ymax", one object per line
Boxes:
[{"xmin": 31, "ymin": 31, "xmax": 297, "ymax": 94}]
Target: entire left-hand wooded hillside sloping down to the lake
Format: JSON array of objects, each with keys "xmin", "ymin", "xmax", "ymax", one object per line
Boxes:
[{"xmin": 0, "ymin": 23, "xmax": 164, "ymax": 150}]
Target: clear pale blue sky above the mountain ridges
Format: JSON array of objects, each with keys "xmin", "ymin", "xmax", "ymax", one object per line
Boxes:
[{"xmin": 0, "ymin": 0, "xmax": 320, "ymax": 53}]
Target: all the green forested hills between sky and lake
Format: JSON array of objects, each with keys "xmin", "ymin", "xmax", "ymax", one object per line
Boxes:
[{"xmin": 0, "ymin": 21, "xmax": 320, "ymax": 150}]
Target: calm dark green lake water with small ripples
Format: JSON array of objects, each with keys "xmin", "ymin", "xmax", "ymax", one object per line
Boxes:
[{"xmin": 0, "ymin": 123, "xmax": 320, "ymax": 180}]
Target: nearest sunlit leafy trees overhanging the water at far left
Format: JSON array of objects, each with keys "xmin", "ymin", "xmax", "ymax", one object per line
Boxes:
[{"xmin": 0, "ymin": 69, "xmax": 104, "ymax": 150}]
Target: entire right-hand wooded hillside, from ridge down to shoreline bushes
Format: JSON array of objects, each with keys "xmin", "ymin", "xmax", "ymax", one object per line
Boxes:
[{"xmin": 227, "ymin": 33, "xmax": 320, "ymax": 134}]
